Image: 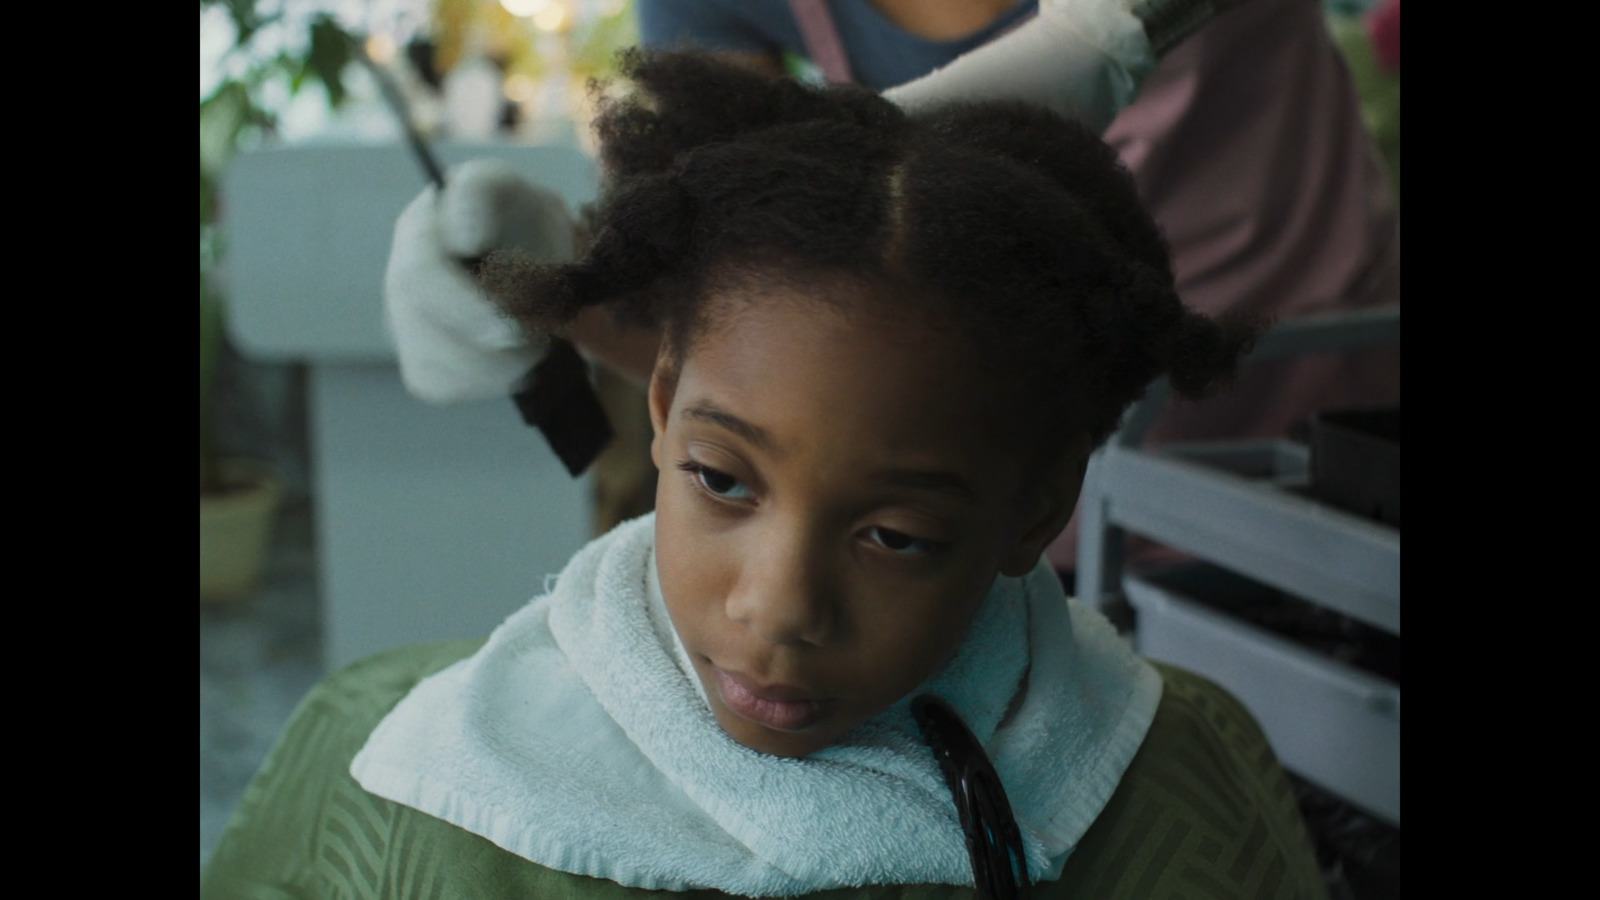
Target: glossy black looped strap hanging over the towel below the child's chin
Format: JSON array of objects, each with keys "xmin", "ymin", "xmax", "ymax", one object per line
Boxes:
[{"xmin": 910, "ymin": 693, "xmax": 1030, "ymax": 900}]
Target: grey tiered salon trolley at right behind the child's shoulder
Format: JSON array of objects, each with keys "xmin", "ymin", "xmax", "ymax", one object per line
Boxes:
[{"xmin": 1077, "ymin": 307, "xmax": 1400, "ymax": 825}]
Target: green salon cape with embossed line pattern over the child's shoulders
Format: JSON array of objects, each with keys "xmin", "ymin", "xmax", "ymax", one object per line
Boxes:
[{"xmin": 200, "ymin": 641, "xmax": 1326, "ymax": 900}]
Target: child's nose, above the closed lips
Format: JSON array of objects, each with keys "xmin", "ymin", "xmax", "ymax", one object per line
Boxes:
[{"xmin": 726, "ymin": 531, "xmax": 838, "ymax": 645}]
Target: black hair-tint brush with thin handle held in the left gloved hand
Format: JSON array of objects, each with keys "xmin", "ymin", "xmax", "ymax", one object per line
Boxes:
[{"xmin": 350, "ymin": 38, "xmax": 613, "ymax": 477}]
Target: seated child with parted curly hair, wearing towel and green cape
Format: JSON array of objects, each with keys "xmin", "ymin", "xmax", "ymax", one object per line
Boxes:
[{"xmin": 203, "ymin": 56, "xmax": 1322, "ymax": 898}]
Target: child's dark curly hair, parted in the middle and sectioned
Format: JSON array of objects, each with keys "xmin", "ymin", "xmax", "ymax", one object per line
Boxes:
[{"xmin": 482, "ymin": 51, "xmax": 1261, "ymax": 447}]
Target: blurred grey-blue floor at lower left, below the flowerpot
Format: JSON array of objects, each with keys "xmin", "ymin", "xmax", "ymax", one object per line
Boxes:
[{"xmin": 200, "ymin": 501, "xmax": 322, "ymax": 865}]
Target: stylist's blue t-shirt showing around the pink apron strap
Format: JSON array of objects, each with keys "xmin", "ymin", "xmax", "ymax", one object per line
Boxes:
[{"xmin": 637, "ymin": 0, "xmax": 1038, "ymax": 91}]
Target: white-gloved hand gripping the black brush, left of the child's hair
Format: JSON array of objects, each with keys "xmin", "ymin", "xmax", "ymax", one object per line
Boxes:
[{"xmin": 384, "ymin": 160, "xmax": 573, "ymax": 404}]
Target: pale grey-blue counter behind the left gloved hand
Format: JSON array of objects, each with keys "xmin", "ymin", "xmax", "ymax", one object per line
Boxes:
[{"xmin": 222, "ymin": 143, "xmax": 595, "ymax": 669}]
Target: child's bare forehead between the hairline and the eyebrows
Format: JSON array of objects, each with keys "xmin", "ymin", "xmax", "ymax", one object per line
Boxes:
[{"xmin": 674, "ymin": 285, "xmax": 1011, "ymax": 486}]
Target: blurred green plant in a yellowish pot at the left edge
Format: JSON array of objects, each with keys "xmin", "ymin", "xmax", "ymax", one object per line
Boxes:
[{"xmin": 200, "ymin": 0, "xmax": 352, "ymax": 602}]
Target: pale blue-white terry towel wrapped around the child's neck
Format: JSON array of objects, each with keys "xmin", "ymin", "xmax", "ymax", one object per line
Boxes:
[{"xmin": 350, "ymin": 516, "xmax": 1162, "ymax": 897}]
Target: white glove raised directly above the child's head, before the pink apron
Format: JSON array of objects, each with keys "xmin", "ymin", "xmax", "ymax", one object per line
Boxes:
[{"xmin": 883, "ymin": 0, "xmax": 1155, "ymax": 133}]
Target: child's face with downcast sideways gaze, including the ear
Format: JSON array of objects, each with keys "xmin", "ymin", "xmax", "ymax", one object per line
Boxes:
[{"xmin": 650, "ymin": 287, "xmax": 1082, "ymax": 756}]
